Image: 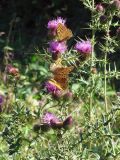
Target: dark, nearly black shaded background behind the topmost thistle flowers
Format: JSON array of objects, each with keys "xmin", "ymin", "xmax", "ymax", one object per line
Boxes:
[{"xmin": 0, "ymin": 0, "xmax": 120, "ymax": 90}]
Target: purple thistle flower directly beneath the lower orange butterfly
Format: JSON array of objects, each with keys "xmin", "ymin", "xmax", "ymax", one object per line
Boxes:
[{"xmin": 45, "ymin": 82, "xmax": 59, "ymax": 93}]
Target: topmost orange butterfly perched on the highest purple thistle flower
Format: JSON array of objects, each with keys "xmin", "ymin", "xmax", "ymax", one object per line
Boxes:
[{"xmin": 56, "ymin": 23, "xmax": 73, "ymax": 41}]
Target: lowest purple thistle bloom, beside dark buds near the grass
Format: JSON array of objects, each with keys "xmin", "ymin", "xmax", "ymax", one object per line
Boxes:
[{"xmin": 43, "ymin": 112, "xmax": 60, "ymax": 126}]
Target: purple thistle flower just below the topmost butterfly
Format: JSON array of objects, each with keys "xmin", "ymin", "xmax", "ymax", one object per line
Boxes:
[{"xmin": 48, "ymin": 41, "xmax": 67, "ymax": 54}]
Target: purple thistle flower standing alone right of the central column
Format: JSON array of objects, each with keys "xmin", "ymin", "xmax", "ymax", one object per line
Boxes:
[{"xmin": 75, "ymin": 40, "xmax": 92, "ymax": 55}]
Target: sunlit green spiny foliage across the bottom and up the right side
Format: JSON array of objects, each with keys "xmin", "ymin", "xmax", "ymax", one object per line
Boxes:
[{"xmin": 0, "ymin": 0, "xmax": 120, "ymax": 160}]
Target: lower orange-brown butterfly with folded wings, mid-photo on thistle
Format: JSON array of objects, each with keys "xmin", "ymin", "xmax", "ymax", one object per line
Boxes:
[{"xmin": 53, "ymin": 66, "xmax": 74, "ymax": 90}]
